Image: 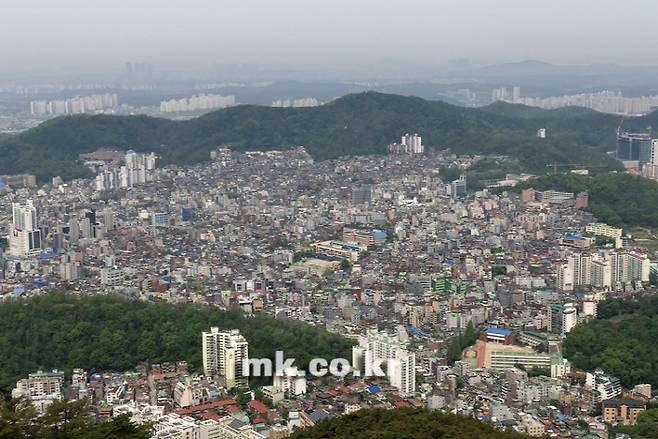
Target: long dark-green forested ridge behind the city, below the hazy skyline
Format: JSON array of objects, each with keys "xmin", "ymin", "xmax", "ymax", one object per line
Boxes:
[{"xmin": 0, "ymin": 92, "xmax": 621, "ymax": 179}]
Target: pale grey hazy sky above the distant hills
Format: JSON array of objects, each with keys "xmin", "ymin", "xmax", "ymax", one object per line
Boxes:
[{"xmin": 0, "ymin": 0, "xmax": 658, "ymax": 74}]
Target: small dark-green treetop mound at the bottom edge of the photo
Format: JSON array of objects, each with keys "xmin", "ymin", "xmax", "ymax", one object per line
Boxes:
[{"xmin": 290, "ymin": 409, "xmax": 529, "ymax": 439}]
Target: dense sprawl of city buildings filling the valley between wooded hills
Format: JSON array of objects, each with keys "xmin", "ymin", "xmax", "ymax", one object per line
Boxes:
[{"xmin": 0, "ymin": 145, "xmax": 655, "ymax": 438}]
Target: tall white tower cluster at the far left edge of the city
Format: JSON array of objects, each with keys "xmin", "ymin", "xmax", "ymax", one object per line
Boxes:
[{"xmin": 9, "ymin": 200, "xmax": 41, "ymax": 257}]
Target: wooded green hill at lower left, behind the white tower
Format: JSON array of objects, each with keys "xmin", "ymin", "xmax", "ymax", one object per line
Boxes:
[{"xmin": 0, "ymin": 294, "xmax": 352, "ymax": 387}]
